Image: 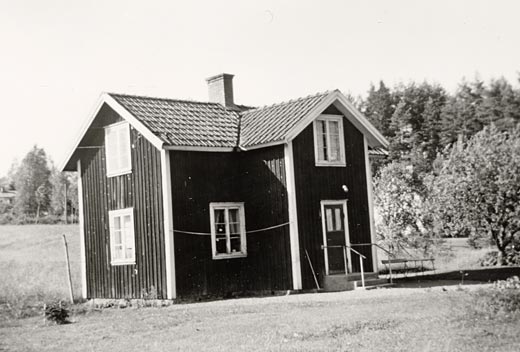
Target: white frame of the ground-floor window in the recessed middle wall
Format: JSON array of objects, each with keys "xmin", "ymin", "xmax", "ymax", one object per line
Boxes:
[{"xmin": 209, "ymin": 202, "xmax": 247, "ymax": 259}]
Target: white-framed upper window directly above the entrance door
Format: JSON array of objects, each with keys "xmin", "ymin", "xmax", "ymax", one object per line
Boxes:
[{"xmin": 314, "ymin": 115, "xmax": 346, "ymax": 166}]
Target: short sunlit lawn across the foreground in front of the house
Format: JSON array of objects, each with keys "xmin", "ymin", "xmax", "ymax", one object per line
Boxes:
[{"xmin": 0, "ymin": 286, "xmax": 520, "ymax": 352}]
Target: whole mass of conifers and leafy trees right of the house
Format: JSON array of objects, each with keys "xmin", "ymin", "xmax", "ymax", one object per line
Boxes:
[{"xmin": 356, "ymin": 77, "xmax": 520, "ymax": 264}]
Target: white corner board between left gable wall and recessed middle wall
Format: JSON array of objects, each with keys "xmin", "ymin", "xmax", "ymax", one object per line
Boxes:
[{"xmin": 161, "ymin": 149, "xmax": 177, "ymax": 299}]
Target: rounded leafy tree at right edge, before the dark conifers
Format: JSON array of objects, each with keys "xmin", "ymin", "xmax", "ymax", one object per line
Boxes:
[{"xmin": 428, "ymin": 125, "xmax": 520, "ymax": 264}]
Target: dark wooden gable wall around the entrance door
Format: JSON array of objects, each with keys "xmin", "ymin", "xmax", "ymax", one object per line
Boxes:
[{"xmin": 293, "ymin": 106, "xmax": 372, "ymax": 288}]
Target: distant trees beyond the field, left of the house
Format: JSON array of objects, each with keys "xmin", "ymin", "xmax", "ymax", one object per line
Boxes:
[{"xmin": 0, "ymin": 145, "xmax": 78, "ymax": 224}]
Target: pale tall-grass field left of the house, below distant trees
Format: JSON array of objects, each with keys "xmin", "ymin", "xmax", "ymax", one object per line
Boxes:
[{"xmin": 0, "ymin": 225, "xmax": 80, "ymax": 315}]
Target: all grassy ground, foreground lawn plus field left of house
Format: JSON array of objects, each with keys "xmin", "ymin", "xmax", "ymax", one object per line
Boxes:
[{"xmin": 0, "ymin": 226, "xmax": 520, "ymax": 352}]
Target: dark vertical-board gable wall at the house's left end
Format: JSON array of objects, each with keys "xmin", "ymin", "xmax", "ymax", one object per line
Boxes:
[{"xmin": 80, "ymin": 105, "xmax": 166, "ymax": 298}]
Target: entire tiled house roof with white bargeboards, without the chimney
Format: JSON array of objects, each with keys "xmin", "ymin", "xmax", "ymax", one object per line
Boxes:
[{"xmin": 62, "ymin": 90, "xmax": 388, "ymax": 171}]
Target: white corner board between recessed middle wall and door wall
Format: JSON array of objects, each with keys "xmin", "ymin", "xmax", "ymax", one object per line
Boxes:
[{"xmin": 284, "ymin": 142, "xmax": 302, "ymax": 290}]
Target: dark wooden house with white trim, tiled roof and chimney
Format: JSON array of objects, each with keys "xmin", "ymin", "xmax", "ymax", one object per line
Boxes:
[{"xmin": 62, "ymin": 74, "xmax": 387, "ymax": 299}]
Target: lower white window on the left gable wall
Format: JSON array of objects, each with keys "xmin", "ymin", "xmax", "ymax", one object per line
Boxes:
[{"xmin": 108, "ymin": 208, "xmax": 135, "ymax": 265}]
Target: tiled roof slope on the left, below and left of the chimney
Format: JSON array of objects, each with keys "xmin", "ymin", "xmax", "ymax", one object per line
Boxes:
[{"xmin": 110, "ymin": 93, "xmax": 239, "ymax": 148}]
